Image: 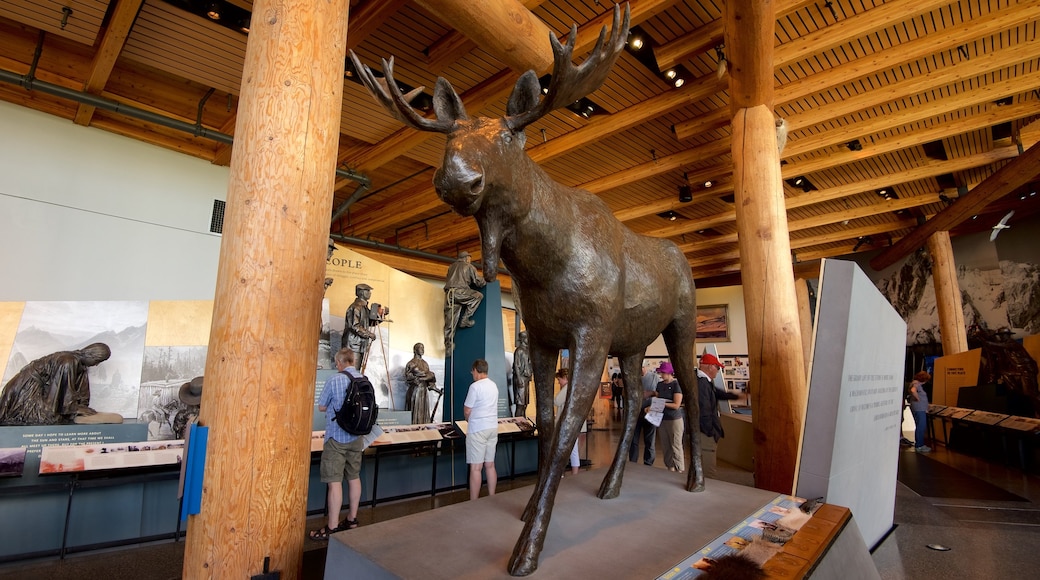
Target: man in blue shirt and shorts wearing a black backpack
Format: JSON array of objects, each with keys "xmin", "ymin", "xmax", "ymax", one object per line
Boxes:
[{"xmin": 310, "ymin": 348, "xmax": 364, "ymax": 539}]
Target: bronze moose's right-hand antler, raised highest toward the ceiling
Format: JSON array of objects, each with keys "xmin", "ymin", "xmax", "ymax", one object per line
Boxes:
[{"xmin": 504, "ymin": 4, "xmax": 629, "ymax": 131}]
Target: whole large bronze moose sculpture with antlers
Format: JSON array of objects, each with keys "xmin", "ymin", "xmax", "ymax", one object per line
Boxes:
[{"xmin": 352, "ymin": 6, "xmax": 704, "ymax": 576}]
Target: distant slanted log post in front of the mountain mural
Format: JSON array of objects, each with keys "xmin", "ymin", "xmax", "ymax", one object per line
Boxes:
[{"xmin": 928, "ymin": 232, "xmax": 968, "ymax": 354}]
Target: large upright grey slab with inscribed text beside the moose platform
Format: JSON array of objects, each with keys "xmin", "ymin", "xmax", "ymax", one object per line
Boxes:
[{"xmin": 796, "ymin": 260, "xmax": 906, "ymax": 546}]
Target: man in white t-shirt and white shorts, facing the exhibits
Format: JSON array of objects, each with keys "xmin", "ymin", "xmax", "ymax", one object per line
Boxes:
[{"xmin": 463, "ymin": 359, "xmax": 498, "ymax": 500}]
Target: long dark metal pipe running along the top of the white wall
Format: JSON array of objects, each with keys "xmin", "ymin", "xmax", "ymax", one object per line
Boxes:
[{"xmin": 0, "ymin": 70, "xmax": 371, "ymax": 188}]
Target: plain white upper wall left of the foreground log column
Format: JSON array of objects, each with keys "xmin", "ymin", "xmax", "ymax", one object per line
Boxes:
[{"xmin": 0, "ymin": 103, "xmax": 229, "ymax": 301}]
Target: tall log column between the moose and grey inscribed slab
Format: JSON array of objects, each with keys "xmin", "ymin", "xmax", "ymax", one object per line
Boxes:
[{"xmin": 726, "ymin": 0, "xmax": 807, "ymax": 493}]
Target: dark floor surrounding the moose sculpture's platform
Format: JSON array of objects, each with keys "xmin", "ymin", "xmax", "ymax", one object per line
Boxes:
[{"xmin": 0, "ymin": 401, "xmax": 1040, "ymax": 580}]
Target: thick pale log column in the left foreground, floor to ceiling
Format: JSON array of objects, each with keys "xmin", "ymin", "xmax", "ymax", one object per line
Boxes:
[{"xmin": 183, "ymin": 0, "xmax": 347, "ymax": 579}]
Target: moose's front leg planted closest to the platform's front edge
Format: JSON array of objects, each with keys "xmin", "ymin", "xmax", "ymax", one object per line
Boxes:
[{"xmin": 510, "ymin": 340, "xmax": 607, "ymax": 576}]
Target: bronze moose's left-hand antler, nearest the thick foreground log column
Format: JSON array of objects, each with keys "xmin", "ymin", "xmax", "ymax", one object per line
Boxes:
[{"xmin": 350, "ymin": 50, "xmax": 466, "ymax": 133}]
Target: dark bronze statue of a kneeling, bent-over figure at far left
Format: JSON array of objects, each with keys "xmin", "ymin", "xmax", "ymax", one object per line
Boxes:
[{"xmin": 0, "ymin": 342, "xmax": 112, "ymax": 425}]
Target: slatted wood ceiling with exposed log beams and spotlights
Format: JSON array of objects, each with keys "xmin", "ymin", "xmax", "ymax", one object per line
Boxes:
[{"xmin": 0, "ymin": 0, "xmax": 1040, "ymax": 284}]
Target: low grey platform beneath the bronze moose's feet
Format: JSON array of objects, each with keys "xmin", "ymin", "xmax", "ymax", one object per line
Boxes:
[{"xmin": 324, "ymin": 464, "xmax": 877, "ymax": 580}]
